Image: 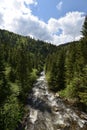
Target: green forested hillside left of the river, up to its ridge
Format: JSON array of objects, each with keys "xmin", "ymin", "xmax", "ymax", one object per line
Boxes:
[{"xmin": 0, "ymin": 30, "xmax": 56, "ymax": 130}]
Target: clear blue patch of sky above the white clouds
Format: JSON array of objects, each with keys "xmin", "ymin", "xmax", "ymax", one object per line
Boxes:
[{"xmin": 31, "ymin": 0, "xmax": 87, "ymax": 22}]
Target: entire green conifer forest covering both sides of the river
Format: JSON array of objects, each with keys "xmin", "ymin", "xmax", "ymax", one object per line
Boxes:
[{"xmin": 0, "ymin": 17, "xmax": 87, "ymax": 130}]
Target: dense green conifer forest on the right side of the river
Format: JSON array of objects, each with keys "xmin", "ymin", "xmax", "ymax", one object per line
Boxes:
[{"xmin": 45, "ymin": 17, "xmax": 87, "ymax": 109}]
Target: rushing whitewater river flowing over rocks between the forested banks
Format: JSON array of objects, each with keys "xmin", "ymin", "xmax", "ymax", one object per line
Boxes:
[{"xmin": 25, "ymin": 72, "xmax": 87, "ymax": 130}]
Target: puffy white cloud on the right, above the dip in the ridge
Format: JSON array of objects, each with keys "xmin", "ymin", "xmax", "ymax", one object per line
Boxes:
[{"xmin": 48, "ymin": 12, "xmax": 84, "ymax": 44}]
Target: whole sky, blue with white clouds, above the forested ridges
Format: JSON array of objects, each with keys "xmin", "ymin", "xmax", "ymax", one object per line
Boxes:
[{"xmin": 0, "ymin": 0, "xmax": 87, "ymax": 45}]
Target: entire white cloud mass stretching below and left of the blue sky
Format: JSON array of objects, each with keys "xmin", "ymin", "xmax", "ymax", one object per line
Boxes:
[{"xmin": 0, "ymin": 0, "xmax": 84, "ymax": 45}]
